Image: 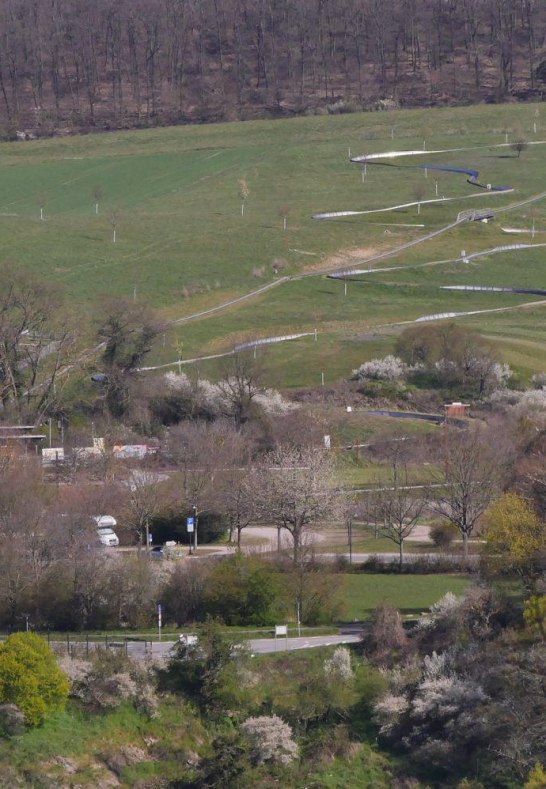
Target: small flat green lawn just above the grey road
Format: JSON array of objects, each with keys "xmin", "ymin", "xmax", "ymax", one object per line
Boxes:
[{"xmin": 345, "ymin": 573, "xmax": 470, "ymax": 620}]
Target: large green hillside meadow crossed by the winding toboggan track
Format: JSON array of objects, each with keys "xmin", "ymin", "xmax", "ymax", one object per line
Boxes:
[{"xmin": 0, "ymin": 105, "xmax": 546, "ymax": 387}]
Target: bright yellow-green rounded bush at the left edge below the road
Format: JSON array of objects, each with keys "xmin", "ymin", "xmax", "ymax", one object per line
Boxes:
[{"xmin": 0, "ymin": 633, "xmax": 69, "ymax": 726}]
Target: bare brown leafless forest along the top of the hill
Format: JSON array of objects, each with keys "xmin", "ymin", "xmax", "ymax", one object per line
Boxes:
[{"xmin": 0, "ymin": 0, "xmax": 546, "ymax": 137}]
